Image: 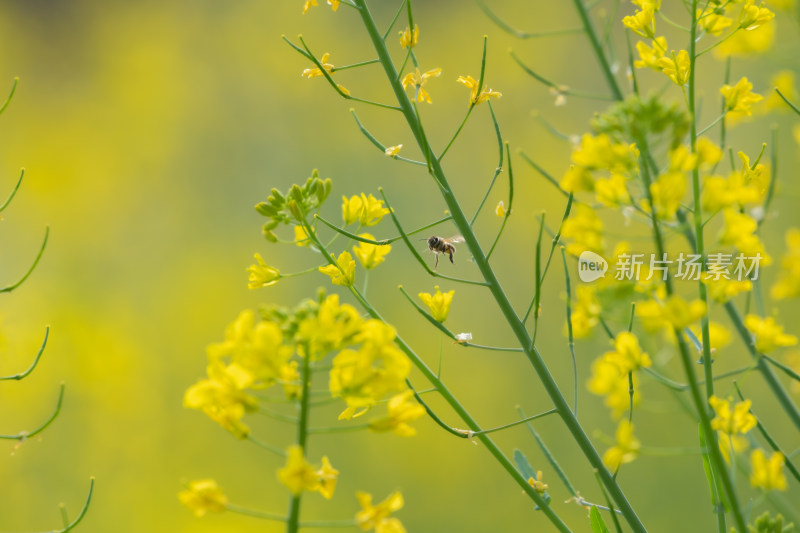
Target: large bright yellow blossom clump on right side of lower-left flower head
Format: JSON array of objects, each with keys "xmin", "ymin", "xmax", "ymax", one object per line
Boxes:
[{"xmin": 329, "ymin": 319, "xmax": 411, "ymax": 419}]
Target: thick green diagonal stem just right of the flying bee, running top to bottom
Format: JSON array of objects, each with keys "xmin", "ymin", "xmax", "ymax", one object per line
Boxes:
[{"xmin": 351, "ymin": 0, "xmax": 646, "ymax": 533}]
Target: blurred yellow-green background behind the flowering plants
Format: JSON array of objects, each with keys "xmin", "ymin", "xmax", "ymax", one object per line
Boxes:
[{"xmin": 0, "ymin": 0, "xmax": 800, "ymax": 533}]
